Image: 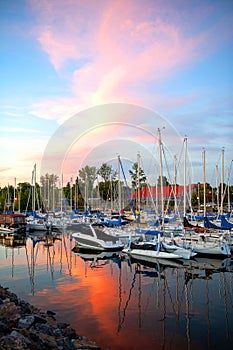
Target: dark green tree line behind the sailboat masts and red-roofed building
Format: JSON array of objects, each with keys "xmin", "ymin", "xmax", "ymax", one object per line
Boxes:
[{"xmin": 0, "ymin": 162, "xmax": 233, "ymax": 212}]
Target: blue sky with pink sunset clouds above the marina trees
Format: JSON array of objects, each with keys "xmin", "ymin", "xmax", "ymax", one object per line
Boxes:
[{"xmin": 0, "ymin": 0, "xmax": 233, "ymax": 187}]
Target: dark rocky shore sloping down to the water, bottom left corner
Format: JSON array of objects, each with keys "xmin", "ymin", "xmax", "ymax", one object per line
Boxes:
[{"xmin": 0, "ymin": 286, "xmax": 101, "ymax": 350}]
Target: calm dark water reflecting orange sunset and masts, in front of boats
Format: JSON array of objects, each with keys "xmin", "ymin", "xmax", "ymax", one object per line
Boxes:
[{"xmin": 0, "ymin": 233, "xmax": 233, "ymax": 350}]
